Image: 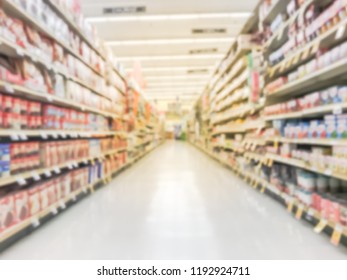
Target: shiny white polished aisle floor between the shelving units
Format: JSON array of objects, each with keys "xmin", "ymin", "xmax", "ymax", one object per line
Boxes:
[{"xmin": 0, "ymin": 142, "xmax": 347, "ymax": 259}]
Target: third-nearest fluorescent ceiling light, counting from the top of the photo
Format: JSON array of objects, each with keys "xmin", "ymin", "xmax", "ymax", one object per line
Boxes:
[{"xmin": 117, "ymin": 54, "xmax": 225, "ymax": 61}]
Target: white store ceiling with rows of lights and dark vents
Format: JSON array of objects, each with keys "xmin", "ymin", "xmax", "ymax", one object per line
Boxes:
[{"xmin": 81, "ymin": 0, "xmax": 258, "ymax": 109}]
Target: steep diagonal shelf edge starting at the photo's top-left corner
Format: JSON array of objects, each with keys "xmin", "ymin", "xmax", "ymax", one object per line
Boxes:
[{"xmin": 2, "ymin": 0, "xmax": 102, "ymax": 76}]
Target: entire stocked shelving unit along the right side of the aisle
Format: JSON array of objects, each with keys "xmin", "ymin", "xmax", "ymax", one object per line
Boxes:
[{"xmin": 189, "ymin": 0, "xmax": 347, "ymax": 245}]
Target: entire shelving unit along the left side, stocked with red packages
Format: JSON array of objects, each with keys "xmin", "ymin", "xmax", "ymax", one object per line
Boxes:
[{"xmin": 0, "ymin": 0, "xmax": 162, "ymax": 251}]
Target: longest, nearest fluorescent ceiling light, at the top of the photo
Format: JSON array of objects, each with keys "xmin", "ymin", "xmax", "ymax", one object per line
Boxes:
[{"xmin": 87, "ymin": 12, "xmax": 252, "ymax": 22}]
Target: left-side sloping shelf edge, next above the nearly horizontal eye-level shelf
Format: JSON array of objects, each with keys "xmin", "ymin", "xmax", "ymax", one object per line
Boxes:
[{"xmin": 0, "ymin": 81, "xmax": 119, "ymax": 119}]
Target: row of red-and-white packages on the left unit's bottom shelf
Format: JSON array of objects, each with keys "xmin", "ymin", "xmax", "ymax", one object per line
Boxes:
[{"xmin": 0, "ymin": 152, "xmax": 132, "ymax": 235}]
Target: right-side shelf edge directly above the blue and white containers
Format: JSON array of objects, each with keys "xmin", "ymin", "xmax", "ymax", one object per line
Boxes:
[{"xmin": 264, "ymin": 103, "xmax": 347, "ymax": 121}]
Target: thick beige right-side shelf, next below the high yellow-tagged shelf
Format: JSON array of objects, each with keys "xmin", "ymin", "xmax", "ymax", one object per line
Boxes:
[{"xmin": 267, "ymin": 58, "xmax": 347, "ymax": 99}]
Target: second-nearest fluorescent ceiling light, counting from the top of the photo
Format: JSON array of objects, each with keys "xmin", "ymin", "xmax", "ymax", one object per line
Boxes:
[{"xmin": 106, "ymin": 37, "xmax": 235, "ymax": 46}]
